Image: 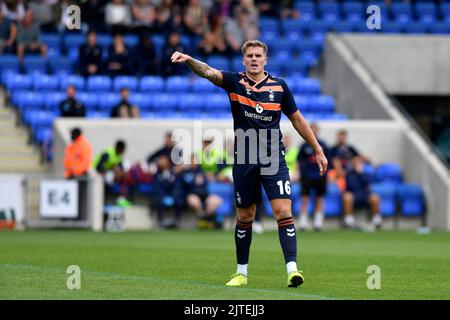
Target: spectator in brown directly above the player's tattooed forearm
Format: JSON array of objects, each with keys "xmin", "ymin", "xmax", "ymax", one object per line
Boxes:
[{"xmin": 199, "ymin": 14, "xmax": 229, "ymax": 57}]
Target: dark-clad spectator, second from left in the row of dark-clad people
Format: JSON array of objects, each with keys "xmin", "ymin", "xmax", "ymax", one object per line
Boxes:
[{"xmin": 106, "ymin": 33, "xmax": 131, "ymax": 76}]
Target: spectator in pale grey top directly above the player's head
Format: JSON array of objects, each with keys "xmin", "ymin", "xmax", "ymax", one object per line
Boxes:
[{"xmin": 225, "ymin": 9, "xmax": 259, "ymax": 55}]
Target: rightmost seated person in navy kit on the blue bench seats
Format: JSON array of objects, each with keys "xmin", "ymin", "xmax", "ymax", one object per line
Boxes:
[{"xmin": 343, "ymin": 156, "xmax": 382, "ymax": 229}]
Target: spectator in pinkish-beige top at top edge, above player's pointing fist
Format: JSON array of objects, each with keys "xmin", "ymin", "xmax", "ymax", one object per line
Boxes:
[{"xmin": 183, "ymin": 0, "xmax": 209, "ymax": 37}]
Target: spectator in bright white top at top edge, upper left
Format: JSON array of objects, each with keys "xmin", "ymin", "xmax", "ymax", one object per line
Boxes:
[{"xmin": 105, "ymin": 0, "xmax": 131, "ymax": 33}]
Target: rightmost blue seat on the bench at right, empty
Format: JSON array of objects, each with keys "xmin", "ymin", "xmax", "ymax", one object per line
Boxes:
[{"xmin": 397, "ymin": 184, "xmax": 425, "ymax": 217}]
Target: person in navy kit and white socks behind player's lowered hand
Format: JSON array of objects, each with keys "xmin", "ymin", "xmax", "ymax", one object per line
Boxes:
[{"xmin": 297, "ymin": 123, "xmax": 328, "ymax": 231}]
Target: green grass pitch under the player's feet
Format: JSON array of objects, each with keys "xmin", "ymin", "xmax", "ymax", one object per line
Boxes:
[{"xmin": 0, "ymin": 230, "xmax": 450, "ymax": 300}]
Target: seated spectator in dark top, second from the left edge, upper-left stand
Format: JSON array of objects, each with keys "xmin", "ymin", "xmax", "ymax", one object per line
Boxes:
[{"xmin": 17, "ymin": 10, "xmax": 47, "ymax": 61}]
